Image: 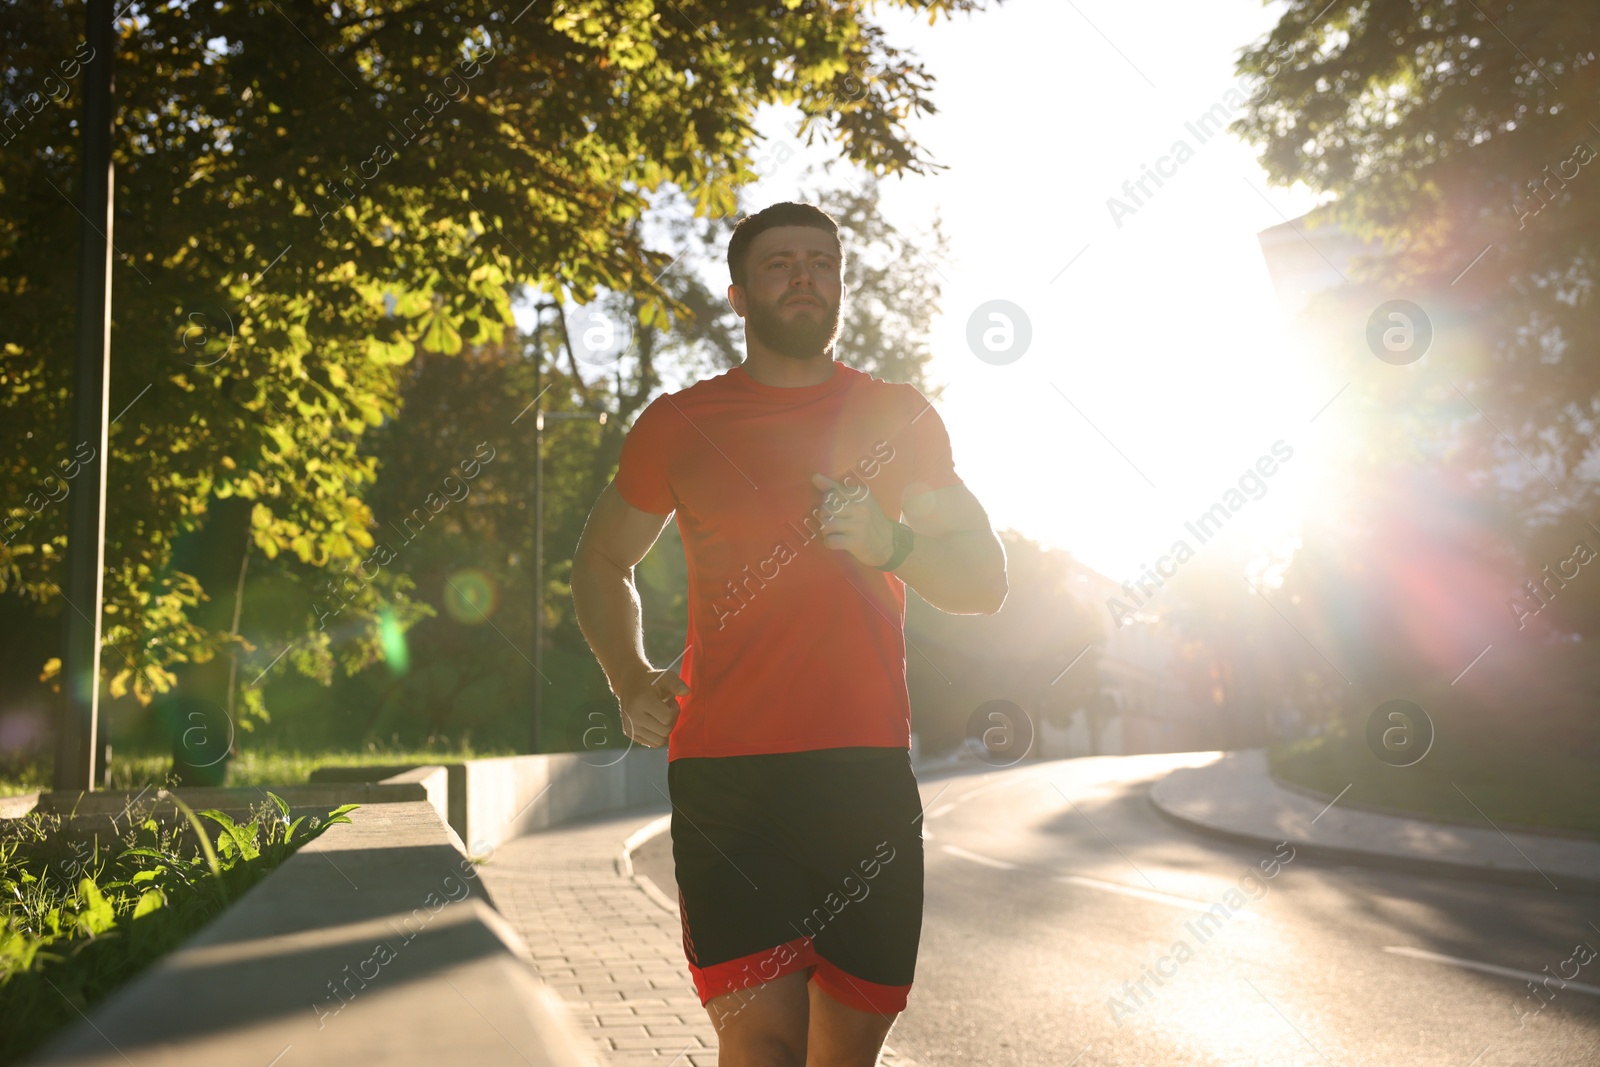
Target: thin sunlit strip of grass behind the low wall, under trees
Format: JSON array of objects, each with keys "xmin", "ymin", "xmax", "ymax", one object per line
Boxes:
[{"xmin": 0, "ymin": 747, "xmax": 514, "ymax": 797}]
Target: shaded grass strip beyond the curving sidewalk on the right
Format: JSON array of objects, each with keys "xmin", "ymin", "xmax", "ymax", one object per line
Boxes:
[{"xmin": 1267, "ymin": 723, "xmax": 1600, "ymax": 837}]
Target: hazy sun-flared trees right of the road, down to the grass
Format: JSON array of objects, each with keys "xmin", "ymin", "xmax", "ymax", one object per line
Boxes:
[{"xmin": 1235, "ymin": 0, "xmax": 1600, "ymax": 750}]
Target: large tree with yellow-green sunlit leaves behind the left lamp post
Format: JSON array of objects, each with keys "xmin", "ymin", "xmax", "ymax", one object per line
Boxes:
[{"xmin": 0, "ymin": 0, "xmax": 982, "ymax": 751}]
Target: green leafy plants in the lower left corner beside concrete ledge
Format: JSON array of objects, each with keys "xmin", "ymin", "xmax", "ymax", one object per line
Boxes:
[{"xmin": 0, "ymin": 793, "xmax": 355, "ymax": 1062}]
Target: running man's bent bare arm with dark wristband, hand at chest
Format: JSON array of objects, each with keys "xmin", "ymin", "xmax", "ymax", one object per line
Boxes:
[{"xmin": 811, "ymin": 474, "xmax": 1008, "ymax": 614}]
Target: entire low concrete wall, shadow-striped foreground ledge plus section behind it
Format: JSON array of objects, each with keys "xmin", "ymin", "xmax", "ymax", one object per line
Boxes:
[{"xmin": 18, "ymin": 747, "xmax": 667, "ymax": 1067}]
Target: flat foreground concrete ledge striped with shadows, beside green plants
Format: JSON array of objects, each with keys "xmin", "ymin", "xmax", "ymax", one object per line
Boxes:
[{"xmin": 30, "ymin": 799, "xmax": 600, "ymax": 1067}]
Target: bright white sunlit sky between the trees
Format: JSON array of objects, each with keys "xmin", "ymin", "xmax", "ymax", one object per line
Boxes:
[{"xmin": 528, "ymin": 0, "xmax": 1347, "ymax": 581}]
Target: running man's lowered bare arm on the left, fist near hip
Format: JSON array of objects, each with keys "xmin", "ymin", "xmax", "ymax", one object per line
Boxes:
[{"xmin": 573, "ymin": 483, "xmax": 690, "ymax": 749}]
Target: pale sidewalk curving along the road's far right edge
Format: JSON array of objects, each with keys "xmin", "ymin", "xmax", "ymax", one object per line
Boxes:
[{"xmin": 1150, "ymin": 749, "xmax": 1600, "ymax": 893}]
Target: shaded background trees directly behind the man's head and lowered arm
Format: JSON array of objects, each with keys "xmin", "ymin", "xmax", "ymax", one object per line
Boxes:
[{"xmin": 233, "ymin": 167, "xmax": 942, "ymax": 749}]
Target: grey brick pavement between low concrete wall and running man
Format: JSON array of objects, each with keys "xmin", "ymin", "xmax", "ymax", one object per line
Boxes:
[{"xmin": 480, "ymin": 805, "xmax": 917, "ymax": 1067}]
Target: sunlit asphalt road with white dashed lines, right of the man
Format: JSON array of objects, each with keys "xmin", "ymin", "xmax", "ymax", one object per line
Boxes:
[{"xmin": 635, "ymin": 755, "xmax": 1600, "ymax": 1067}]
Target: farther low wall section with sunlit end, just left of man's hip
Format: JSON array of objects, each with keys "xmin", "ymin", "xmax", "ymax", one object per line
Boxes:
[{"xmin": 312, "ymin": 745, "xmax": 667, "ymax": 856}]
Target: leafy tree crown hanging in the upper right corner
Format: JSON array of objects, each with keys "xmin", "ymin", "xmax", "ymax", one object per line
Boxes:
[{"xmin": 1235, "ymin": 0, "xmax": 1600, "ymax": 539}]
